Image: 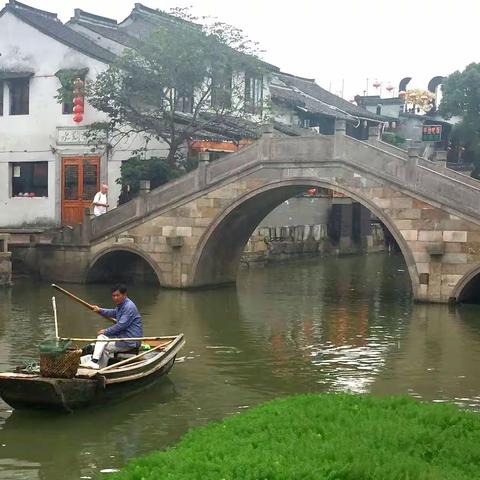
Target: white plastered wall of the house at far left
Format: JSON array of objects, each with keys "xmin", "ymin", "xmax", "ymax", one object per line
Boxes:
[{"xmin": 0, "ymin": 12, "xmax": 169, "ymax": 228}]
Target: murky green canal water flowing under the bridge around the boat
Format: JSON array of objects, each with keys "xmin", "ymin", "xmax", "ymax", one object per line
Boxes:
[{"xmin": 0, "ymin": 254, "xmax": 480, "ymax": 480}]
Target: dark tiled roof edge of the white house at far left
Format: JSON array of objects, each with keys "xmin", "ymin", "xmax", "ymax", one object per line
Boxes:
[{"xmin": 0, "ymin": 0, "xmax": 115, "ymax": 63}]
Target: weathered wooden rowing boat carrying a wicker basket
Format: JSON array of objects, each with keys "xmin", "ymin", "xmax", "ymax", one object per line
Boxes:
[{"xmin": 0, "ymin": 334, "xmax": 185, "ymax": 412}]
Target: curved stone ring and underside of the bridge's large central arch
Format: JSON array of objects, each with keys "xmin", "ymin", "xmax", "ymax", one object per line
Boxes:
[{"xmin": 191, "ymin": 177, "xmax": 419, "ymax": 295}]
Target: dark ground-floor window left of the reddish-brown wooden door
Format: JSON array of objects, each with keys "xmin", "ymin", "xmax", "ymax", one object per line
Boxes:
[{"xmin": 11, "ymin": 162, "xmax": 48, "ymax": 197}]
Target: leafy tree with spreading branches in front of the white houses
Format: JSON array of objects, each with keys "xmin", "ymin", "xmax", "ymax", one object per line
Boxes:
[{"xmin": 87, "ymin": 10, "xmax": 265, "ymax": 169}]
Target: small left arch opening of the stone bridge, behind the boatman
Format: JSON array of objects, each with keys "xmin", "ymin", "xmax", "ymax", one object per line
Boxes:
[{"xmin": 85, "ymin": 245, "xmax": 162, "ymax": 285}]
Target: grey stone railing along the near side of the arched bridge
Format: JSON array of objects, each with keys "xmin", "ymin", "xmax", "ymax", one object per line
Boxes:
[{"xmin": 90, "ymin": 133, "xmax": 480, "ymax": 240}]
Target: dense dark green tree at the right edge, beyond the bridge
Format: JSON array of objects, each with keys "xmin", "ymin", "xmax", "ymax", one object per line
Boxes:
[{"xmin": 440, "ymin": 63, "xmax": 480, "ymax": 177}]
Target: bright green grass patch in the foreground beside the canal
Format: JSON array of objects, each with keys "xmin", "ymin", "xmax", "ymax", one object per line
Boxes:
[{"xmin": 108, "ymin": 394, "xmax": 480, "ymax": 480}]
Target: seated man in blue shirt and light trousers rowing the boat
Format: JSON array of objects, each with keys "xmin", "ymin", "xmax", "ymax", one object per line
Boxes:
[{"xmin": 82, "ymin": 285, "xmax": 143, "ymax": 369}]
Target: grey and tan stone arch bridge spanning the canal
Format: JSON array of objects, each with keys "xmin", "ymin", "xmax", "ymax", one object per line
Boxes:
[{"xmin": 37, "ymin": 122, "xmax": 480, "ymax": 302}]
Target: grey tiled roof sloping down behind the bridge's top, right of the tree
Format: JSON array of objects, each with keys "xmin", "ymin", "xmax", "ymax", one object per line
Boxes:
[{"xmin": 276, "ymin": 73, "xmax": 384, "ymax": 121}]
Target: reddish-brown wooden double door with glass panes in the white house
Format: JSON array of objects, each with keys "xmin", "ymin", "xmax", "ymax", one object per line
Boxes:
[{"xmin": 62, "ymin": 157, "xmax": 100, "ymax": 225}]
